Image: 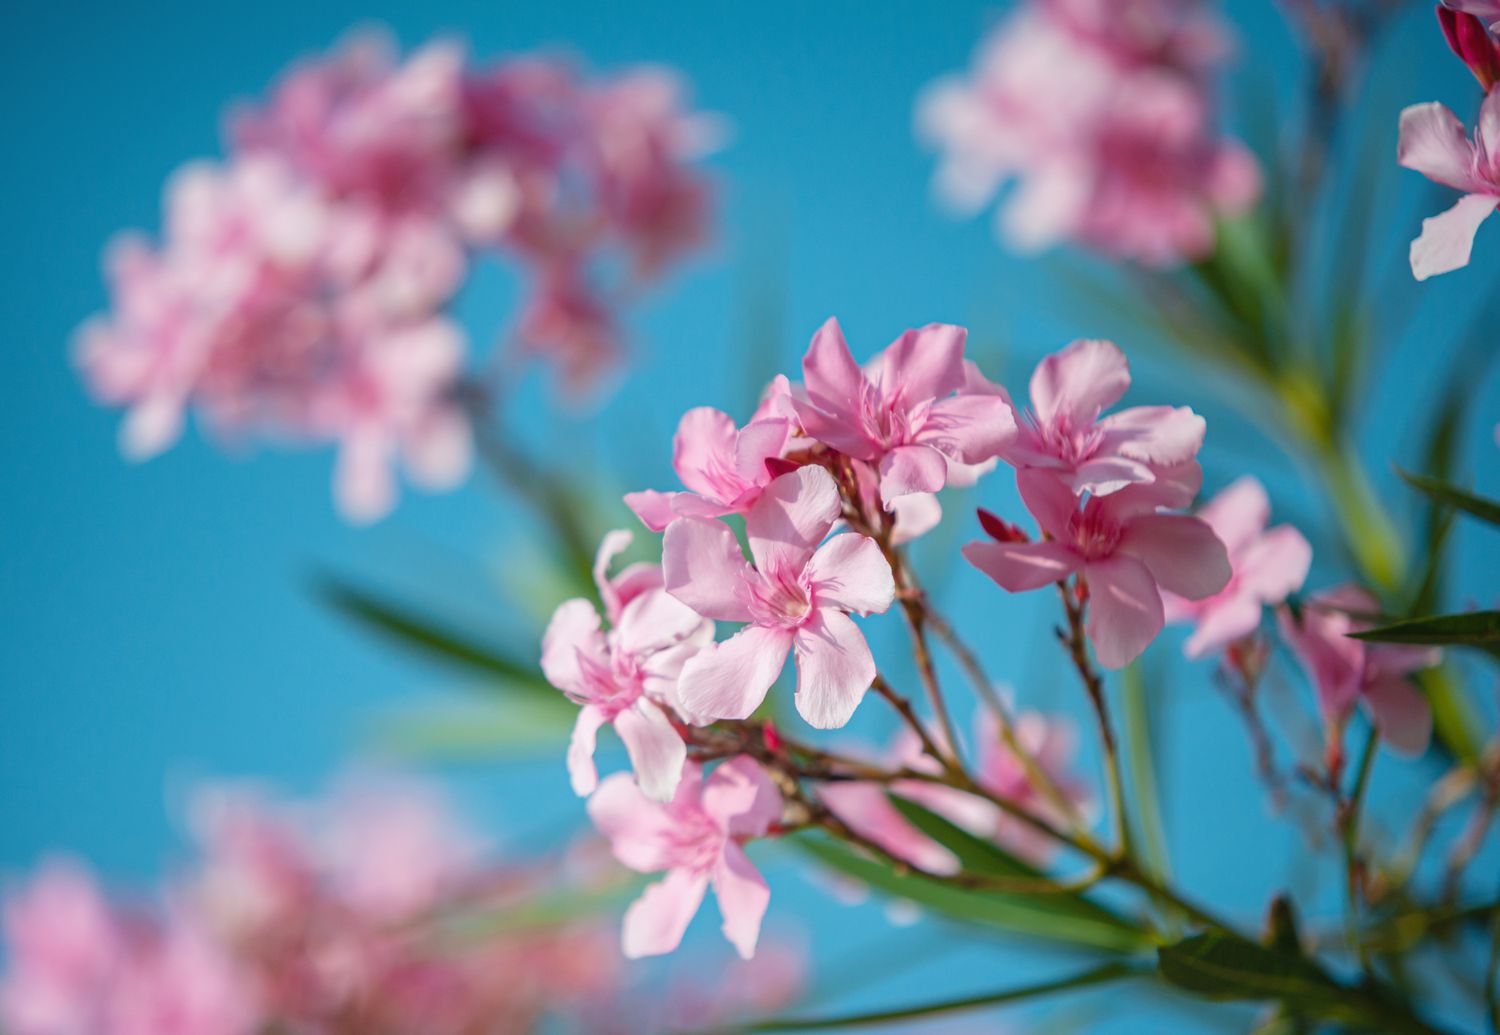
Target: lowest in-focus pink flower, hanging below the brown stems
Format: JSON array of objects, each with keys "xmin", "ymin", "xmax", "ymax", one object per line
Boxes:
[{"xmin": 588, "ymin": 756, "xmax": 782, "ymax": 959}]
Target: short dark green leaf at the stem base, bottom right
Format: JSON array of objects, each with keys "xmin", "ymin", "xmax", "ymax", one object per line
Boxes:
[{"xmin": 1157, "ymin": 935, "xmax": 1344, "ymax": 1008}]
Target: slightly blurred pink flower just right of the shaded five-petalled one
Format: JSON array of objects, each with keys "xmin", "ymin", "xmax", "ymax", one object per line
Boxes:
[{"xmin": 1161, "ymin": 476, "xmax": 1313, "ymax": 657}]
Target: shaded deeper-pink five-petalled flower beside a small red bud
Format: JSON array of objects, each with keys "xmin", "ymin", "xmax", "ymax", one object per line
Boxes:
[{"xmin": 963, "ymin": 464, "xmax": 1232, "ymax": 669}]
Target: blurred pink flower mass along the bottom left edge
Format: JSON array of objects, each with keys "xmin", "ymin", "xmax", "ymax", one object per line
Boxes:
[{"xmin": 0, "ymin": 779, "xmax": 801, "ymax": 1035}]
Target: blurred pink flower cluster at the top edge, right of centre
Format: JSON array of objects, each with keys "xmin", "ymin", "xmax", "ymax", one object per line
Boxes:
[{"xmin": 917, "ymin": 0, "xmax": 1260, "ymax": 266}]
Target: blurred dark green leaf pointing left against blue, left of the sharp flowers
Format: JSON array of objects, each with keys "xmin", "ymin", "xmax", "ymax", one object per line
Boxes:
[{"xmin": 314, "ymin": 576, "xmax": 558, "ymax": 699}]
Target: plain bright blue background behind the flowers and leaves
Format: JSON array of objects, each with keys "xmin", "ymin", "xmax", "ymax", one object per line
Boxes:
[{"xmin": 0, "ymin": 0, "xmax": 1500, "ymax": 1032}]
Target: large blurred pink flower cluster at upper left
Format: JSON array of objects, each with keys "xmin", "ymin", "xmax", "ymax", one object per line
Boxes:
[{"xmin": 77, "ymin": 36, "xmax": 713, "ymax": 521}]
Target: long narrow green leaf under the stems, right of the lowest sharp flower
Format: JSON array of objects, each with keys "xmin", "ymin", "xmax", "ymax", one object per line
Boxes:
[{"xmin": 791, "ymin": 837, "xmax": 1146, "ymax": 953}]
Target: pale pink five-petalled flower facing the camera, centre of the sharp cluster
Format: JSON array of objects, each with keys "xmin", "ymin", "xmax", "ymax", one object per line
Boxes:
[{"xmin": 663, "ymin": 467, "xmax": 896, "ymax": 729}]
